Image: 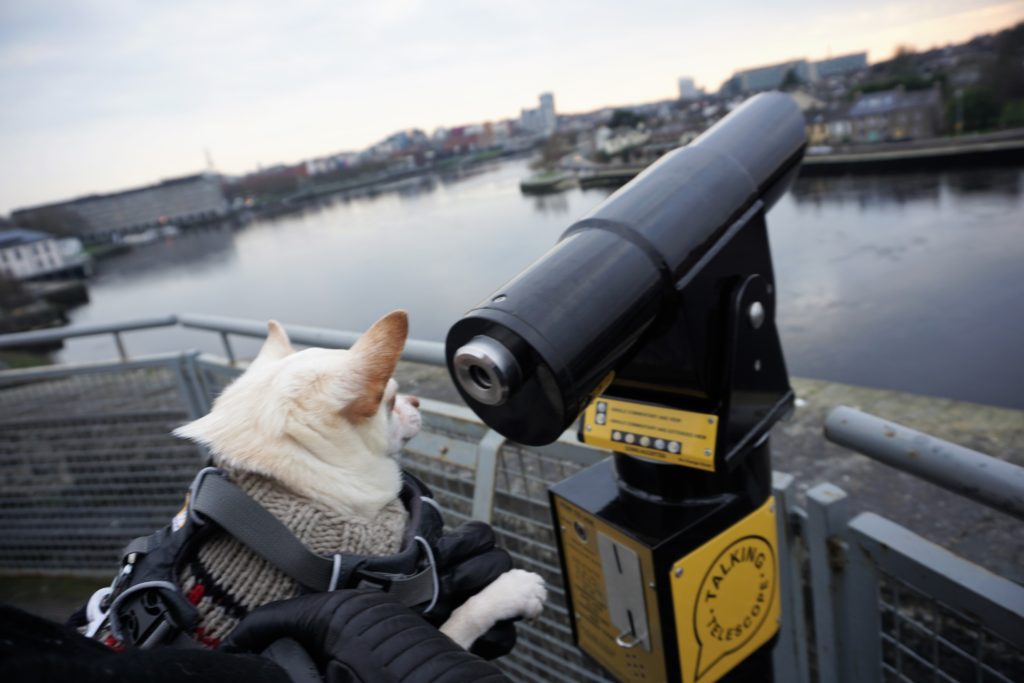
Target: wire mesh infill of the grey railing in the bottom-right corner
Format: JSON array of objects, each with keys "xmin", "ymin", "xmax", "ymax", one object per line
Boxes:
[{"xmin": 879, "ymin": 573, "xmax": 1024, "ymax": 683}]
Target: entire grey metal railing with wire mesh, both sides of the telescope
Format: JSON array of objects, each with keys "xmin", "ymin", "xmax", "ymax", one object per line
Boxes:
[{"xmin": 0, "ymin": 315, "xmax": 1024, "ymax": 682}]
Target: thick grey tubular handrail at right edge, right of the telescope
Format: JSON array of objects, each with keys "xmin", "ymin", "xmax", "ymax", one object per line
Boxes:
[{"xmin": 824, "ymin": 405, "xmax": 1024, "ymax": 520}]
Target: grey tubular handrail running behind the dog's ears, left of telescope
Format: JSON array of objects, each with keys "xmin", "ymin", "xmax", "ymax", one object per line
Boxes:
[{"xmin": 0, "ymin": 313, "xmax": 445, "ymax": 366}]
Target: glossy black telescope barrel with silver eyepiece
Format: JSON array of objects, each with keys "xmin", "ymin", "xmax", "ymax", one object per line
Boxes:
[{"xmin": 445, "ymin": 93, "xmax": 805, "ymax": 445}]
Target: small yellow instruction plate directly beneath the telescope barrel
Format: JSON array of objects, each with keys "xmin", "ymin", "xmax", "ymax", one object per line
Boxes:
[{"xmin": 583, "ymin": 396, "xmax": 718, "ymax": 472}]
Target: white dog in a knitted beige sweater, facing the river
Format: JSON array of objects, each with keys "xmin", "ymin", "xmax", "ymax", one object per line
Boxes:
[{"xmin": 174, "ymin": 310, "xmax": 547, "ymax": 649}]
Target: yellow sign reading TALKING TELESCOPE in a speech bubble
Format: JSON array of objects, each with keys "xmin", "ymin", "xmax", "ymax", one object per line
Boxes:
[{"xmin": 670, "ymin": 497, "xmax": 780, "ymax": 683}]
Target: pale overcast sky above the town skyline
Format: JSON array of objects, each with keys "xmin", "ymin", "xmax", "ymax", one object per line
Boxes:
[{"xmin": 0, "ymin": 0, "xmax": 1024, "ymax": 213}]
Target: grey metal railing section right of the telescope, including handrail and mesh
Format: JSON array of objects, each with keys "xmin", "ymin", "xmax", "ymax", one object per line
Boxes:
[{"xmin": 806, "ymin": 407, "xmax": 1024, "ymax": 683}]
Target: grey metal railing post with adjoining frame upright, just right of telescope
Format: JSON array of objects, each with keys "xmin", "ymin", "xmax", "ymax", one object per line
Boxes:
[{"xmin": 806, "ymin": 483, "xmax": 882, "ymax": 683}]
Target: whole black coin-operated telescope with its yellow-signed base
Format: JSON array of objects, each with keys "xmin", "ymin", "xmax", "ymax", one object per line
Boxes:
[{"xmin": 445, "ymin": 93, "xmax": 805, "ymax": 683}]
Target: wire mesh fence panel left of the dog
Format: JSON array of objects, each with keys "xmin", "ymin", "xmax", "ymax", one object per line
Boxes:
[{"xmin": 0, "ymin": 361, "xmax": 202, "ymax": 574}]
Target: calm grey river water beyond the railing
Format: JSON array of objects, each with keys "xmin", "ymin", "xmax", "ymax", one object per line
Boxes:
[{"xmin": 60, "ymin": 161, "xmax": 1024, "ymax": 409}]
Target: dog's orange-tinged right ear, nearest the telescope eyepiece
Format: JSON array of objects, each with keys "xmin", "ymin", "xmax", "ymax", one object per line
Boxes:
[{"xmin": 343, "ymin": 310, "xmax": 409, "ymax": 421}]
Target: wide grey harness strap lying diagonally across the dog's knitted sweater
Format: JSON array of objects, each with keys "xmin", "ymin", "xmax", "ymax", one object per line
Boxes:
[{"xmin": 190, "ymin": 472, "xmax": 335, "ymax": 591}]
